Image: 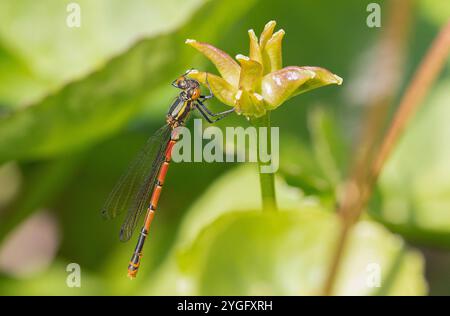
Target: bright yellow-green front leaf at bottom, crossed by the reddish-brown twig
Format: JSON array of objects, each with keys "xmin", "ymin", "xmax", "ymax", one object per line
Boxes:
[{"xmin": 178, "ymin": 210, "xmax": 426, "ymax": 295}]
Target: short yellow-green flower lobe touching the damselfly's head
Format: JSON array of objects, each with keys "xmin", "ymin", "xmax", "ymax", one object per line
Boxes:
[{"xmin": 189, "ymin": 70, "xmax": 237, "ymax": 106}]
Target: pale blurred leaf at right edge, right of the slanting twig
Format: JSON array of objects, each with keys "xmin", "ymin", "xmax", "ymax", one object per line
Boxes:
[{"xmin": 371, "ymin": 79, "xmax": 450, "ymax": 247}]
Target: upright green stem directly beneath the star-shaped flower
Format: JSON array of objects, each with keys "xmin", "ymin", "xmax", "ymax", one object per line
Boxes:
[{"xmin": 251, "ymin": 112, "xmax": 277, "ymax": 212}]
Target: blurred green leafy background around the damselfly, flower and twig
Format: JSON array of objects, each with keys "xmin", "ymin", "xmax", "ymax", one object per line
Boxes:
[{"xmin": 0, "ymin": 0, "xmax": 450, "ymax": 295}]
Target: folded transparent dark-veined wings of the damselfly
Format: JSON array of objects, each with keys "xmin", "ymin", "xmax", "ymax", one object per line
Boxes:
[{"xmin": 102, "ymin": 126, "xmax": 171, "ymax": 241}]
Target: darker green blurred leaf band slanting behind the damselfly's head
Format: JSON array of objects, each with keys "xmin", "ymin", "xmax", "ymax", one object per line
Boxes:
[{"xmin": 0, "ymin": 1, "xmax": 252, "ymax": 162}]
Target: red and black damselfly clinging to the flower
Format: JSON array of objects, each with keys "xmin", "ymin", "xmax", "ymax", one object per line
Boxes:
[{"xmin": 102, "ymin": 70, "xmax": 234, "ymax": 278}]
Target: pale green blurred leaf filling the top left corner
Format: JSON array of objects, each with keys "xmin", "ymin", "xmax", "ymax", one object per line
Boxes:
[{"xmin": 0, "ymin": 0, "xmax": 205, "ymax": 106}]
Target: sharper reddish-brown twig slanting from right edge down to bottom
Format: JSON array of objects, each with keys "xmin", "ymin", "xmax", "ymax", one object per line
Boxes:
[{"xmin": 324, "ymin": 4, "xmax": 450, "ymax": 295}]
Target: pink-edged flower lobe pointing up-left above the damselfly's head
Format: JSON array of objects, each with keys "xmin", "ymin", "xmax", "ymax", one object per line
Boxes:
[{"xmin": 186, "ymin": 39, "xmax": 241, "ymax": 88}]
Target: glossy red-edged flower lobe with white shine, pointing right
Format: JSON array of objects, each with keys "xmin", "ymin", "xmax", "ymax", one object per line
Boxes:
[{"xmin": 261, "ymin": 66, "xmax": 316, "ymax": 110}]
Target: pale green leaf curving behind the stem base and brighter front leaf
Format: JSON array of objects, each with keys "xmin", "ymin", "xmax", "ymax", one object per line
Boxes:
[{"xmin": 142, "ymin": 163, "xmax": 308, "ymax": 295}]
